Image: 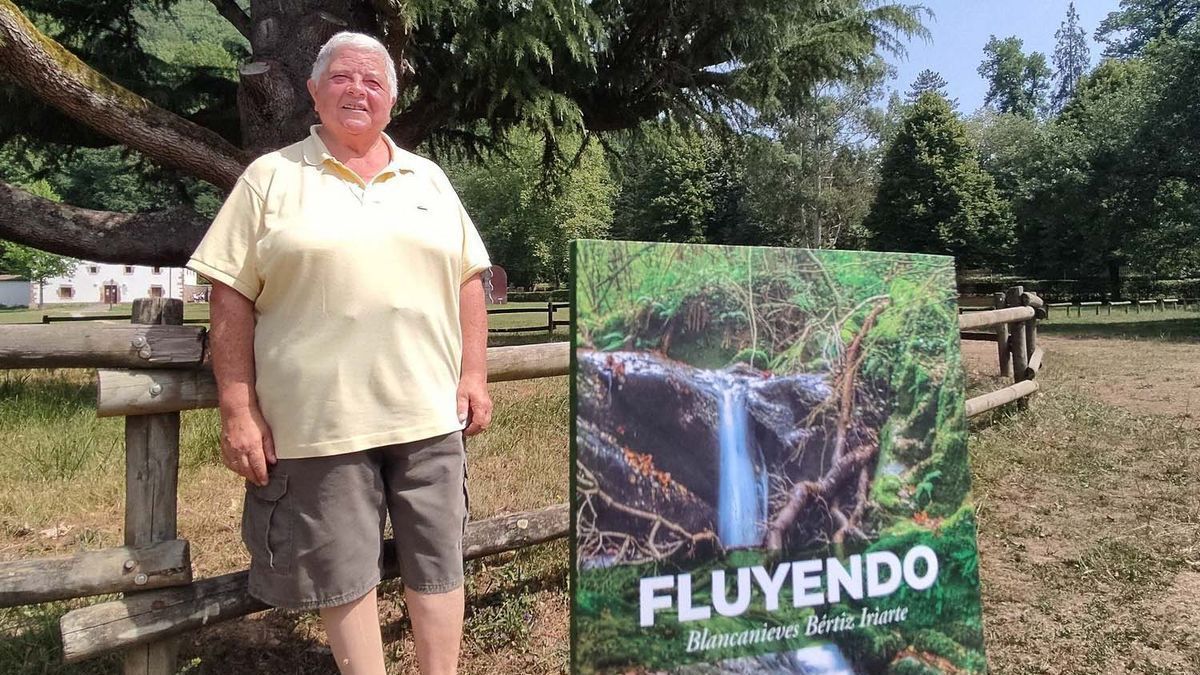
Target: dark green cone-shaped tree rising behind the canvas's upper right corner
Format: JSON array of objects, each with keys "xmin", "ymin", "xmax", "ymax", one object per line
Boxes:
[{"xmin": 863, "ymin": 91, "xmax": 1013, "ymax": 267}]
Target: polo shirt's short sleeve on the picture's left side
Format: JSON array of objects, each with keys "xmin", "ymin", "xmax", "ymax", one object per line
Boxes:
[{"xmin": 187, "ymin": 177, "xmax": 263, "ymax": 300}]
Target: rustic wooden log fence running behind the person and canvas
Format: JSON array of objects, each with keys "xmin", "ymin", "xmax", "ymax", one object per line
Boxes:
[{"xmin": 0, "ymin": 288, "xmax": 1044, "ymax": 675}]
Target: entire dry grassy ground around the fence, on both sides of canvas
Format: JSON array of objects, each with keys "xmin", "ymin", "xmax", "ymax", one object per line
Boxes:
[{"xmin": 0, "ymin": 307, "xmax": 1200, "ymax": 675}]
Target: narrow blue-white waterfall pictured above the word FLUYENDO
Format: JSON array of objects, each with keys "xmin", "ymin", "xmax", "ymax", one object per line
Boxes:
[{"xmin": 716, "ymin": 383, "xmax": 767, "ymax": 549}]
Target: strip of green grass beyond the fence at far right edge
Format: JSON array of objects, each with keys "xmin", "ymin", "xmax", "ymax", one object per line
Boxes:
[{"xmin": 1038, "ymin": 307, "xmax": 1200, "ymax": 342}]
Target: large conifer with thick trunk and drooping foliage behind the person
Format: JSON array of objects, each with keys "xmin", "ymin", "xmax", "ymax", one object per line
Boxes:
[{"xmin": 0, "ymin": 0, "xmax": 925, "ymax": 264}]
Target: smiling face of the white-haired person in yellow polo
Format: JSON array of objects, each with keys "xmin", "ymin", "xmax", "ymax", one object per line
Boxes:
[{"xmin": 308, "ymin": 47, "xmax": 396, "ymax": 138}]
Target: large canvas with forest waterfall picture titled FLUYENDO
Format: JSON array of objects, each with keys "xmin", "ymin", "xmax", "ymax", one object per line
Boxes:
[{"xmin": 571, "ymin": 241, "xmax": 986, "ymax": 675}]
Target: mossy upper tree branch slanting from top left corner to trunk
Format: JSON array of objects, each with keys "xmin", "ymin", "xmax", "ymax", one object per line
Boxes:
[{"xmin": 0, "ymin": 0, "xmax": 250, "ymax": 189}]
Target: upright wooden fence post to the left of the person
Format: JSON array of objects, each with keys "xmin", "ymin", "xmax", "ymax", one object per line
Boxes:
[{"xmin": 124, "ymin": 298, "xmax": 184, "ymax": 675}]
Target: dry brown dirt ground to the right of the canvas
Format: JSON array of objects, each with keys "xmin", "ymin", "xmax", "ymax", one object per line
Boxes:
[{"xmin": 964, "ymin": 338, "xmax": 1200, "ymax": 675}]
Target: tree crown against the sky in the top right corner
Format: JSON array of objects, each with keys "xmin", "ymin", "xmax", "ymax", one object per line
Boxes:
[{"xmin": 1096, "ymin": 0, "xmax": 1200, "ymax": 56}]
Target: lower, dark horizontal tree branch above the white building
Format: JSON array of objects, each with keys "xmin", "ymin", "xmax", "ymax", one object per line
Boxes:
[{"xmin": 0, "ymin": 183, "xmax": 209, "ymax": 267}]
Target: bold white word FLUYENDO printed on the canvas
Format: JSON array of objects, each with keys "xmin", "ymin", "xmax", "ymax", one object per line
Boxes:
[{"xmin": 638, "ymin": 545, "xmax": 937, "ymax": 627}]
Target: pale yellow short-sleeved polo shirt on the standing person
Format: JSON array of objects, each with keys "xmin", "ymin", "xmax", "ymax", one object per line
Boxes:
[{"xmin": 187, "ymin": 126, "xmax": 491, "ymax": 459}]
